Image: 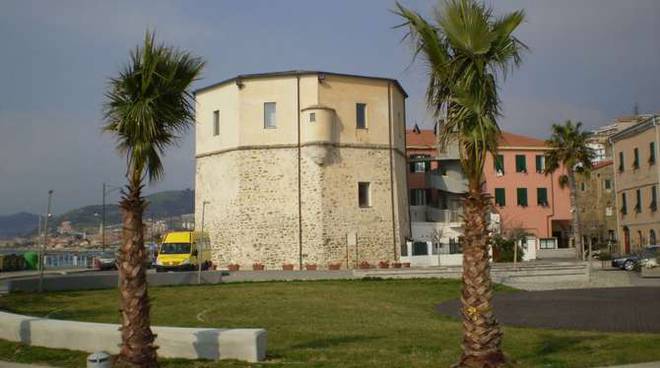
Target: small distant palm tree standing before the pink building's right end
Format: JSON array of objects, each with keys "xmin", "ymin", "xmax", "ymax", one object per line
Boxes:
[{"xmin": 545, "ymin": 120, "xmax": 595, "ymax": 258}]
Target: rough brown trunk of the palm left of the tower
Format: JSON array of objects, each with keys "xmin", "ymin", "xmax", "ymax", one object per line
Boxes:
[{"xmin": 118, "ymin": 175, "xmax": 158, "ymax": 368}]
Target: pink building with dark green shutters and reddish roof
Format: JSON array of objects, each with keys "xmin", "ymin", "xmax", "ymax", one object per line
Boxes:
[{"xmin": 484, "ymin": 132, "xmax": 571, "ymax": 249}]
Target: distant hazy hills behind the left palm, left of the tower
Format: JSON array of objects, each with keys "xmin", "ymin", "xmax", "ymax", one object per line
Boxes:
[{"xmin": 0, "ymin": 189, "xmax": 195, "ymax": 238}]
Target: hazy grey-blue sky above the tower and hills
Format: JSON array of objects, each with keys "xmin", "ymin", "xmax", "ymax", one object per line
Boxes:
[{"xmin": 0, "ymin": 0, "xmax": 660, "ymax": 215}]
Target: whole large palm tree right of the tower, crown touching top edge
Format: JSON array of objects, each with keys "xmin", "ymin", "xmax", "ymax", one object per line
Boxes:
[{"xmin": 395, "ymin": 0, "xmax": 526, "ymax": 368}]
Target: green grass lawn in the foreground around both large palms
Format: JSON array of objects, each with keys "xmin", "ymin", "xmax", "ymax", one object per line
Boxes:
[{"xmin": 0, "ymin": 280, "xmax": 660, "ymax": 368}]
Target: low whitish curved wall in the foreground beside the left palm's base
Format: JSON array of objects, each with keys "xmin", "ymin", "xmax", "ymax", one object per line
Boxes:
[{"xmin": 0, "ymin": 312, "xmax": 266, "ymax": 362}]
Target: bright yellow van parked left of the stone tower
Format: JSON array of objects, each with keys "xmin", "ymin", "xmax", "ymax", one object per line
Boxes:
[{"xmin": 156, "ymin": 231, "xmax": 211, "ymax": 272}]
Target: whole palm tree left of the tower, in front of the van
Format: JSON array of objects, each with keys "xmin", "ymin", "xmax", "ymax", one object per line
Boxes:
[{"xmin": 103, "ymin": 31, "xmax": 204, "ymax": 367}]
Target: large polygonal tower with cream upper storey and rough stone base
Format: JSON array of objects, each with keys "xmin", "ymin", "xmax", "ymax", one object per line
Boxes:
[{"xmin": 195, "ymin": 71, "xmax": 410, "ymax": 269}]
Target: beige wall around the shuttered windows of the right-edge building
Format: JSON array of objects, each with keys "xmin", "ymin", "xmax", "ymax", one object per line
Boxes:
[{"xmin": 612, "ymin": 126, "xmax": 660, "ymax": 252}]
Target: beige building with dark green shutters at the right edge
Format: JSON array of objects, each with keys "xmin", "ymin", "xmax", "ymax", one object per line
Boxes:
[{"xmin": 610, "ymin": 115, "xmax": 660, "ymax": 253}]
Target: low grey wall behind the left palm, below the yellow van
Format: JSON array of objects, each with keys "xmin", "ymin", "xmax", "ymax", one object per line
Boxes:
[{"xmin": 1, "ymin": 271, "xmax": 222, "ymax": 293}]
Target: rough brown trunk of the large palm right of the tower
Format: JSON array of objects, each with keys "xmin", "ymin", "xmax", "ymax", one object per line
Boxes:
[{"xmin": 455, "ymin": 187, "xmax": 505, "ymax": 368}]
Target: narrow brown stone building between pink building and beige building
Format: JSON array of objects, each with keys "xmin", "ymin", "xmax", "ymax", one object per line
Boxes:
[{"xmin": 576, "ymin": 161, "xmax": 618, "ymax": 252}]
